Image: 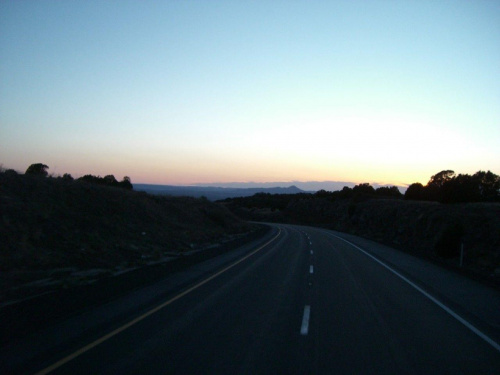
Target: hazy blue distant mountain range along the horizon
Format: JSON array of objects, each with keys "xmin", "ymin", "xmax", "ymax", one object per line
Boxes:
[{"xmin": 134, "ymin": 184, "xmax": 312, "ymax": 201}]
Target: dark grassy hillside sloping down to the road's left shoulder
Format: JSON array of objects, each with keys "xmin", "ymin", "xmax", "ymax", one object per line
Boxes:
[{"xmin": 0, "ymin": 173, "xmax": 253, "ymax": 299}]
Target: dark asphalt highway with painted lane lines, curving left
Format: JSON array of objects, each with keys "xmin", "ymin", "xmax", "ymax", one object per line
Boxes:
[{"xmin": 0, "ymin": 224, "xmax": 500, "ymax": 374}]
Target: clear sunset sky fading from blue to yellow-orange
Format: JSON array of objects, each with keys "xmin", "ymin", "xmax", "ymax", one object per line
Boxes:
[{"xmin": 0, "ymin": 0, "xmax": 500, "ymax": 185}]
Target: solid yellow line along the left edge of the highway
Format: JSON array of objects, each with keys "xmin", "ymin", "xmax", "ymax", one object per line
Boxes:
[{"xmin": 35, "ymin": 228, "xmax": 281, "ymax": 375}]
